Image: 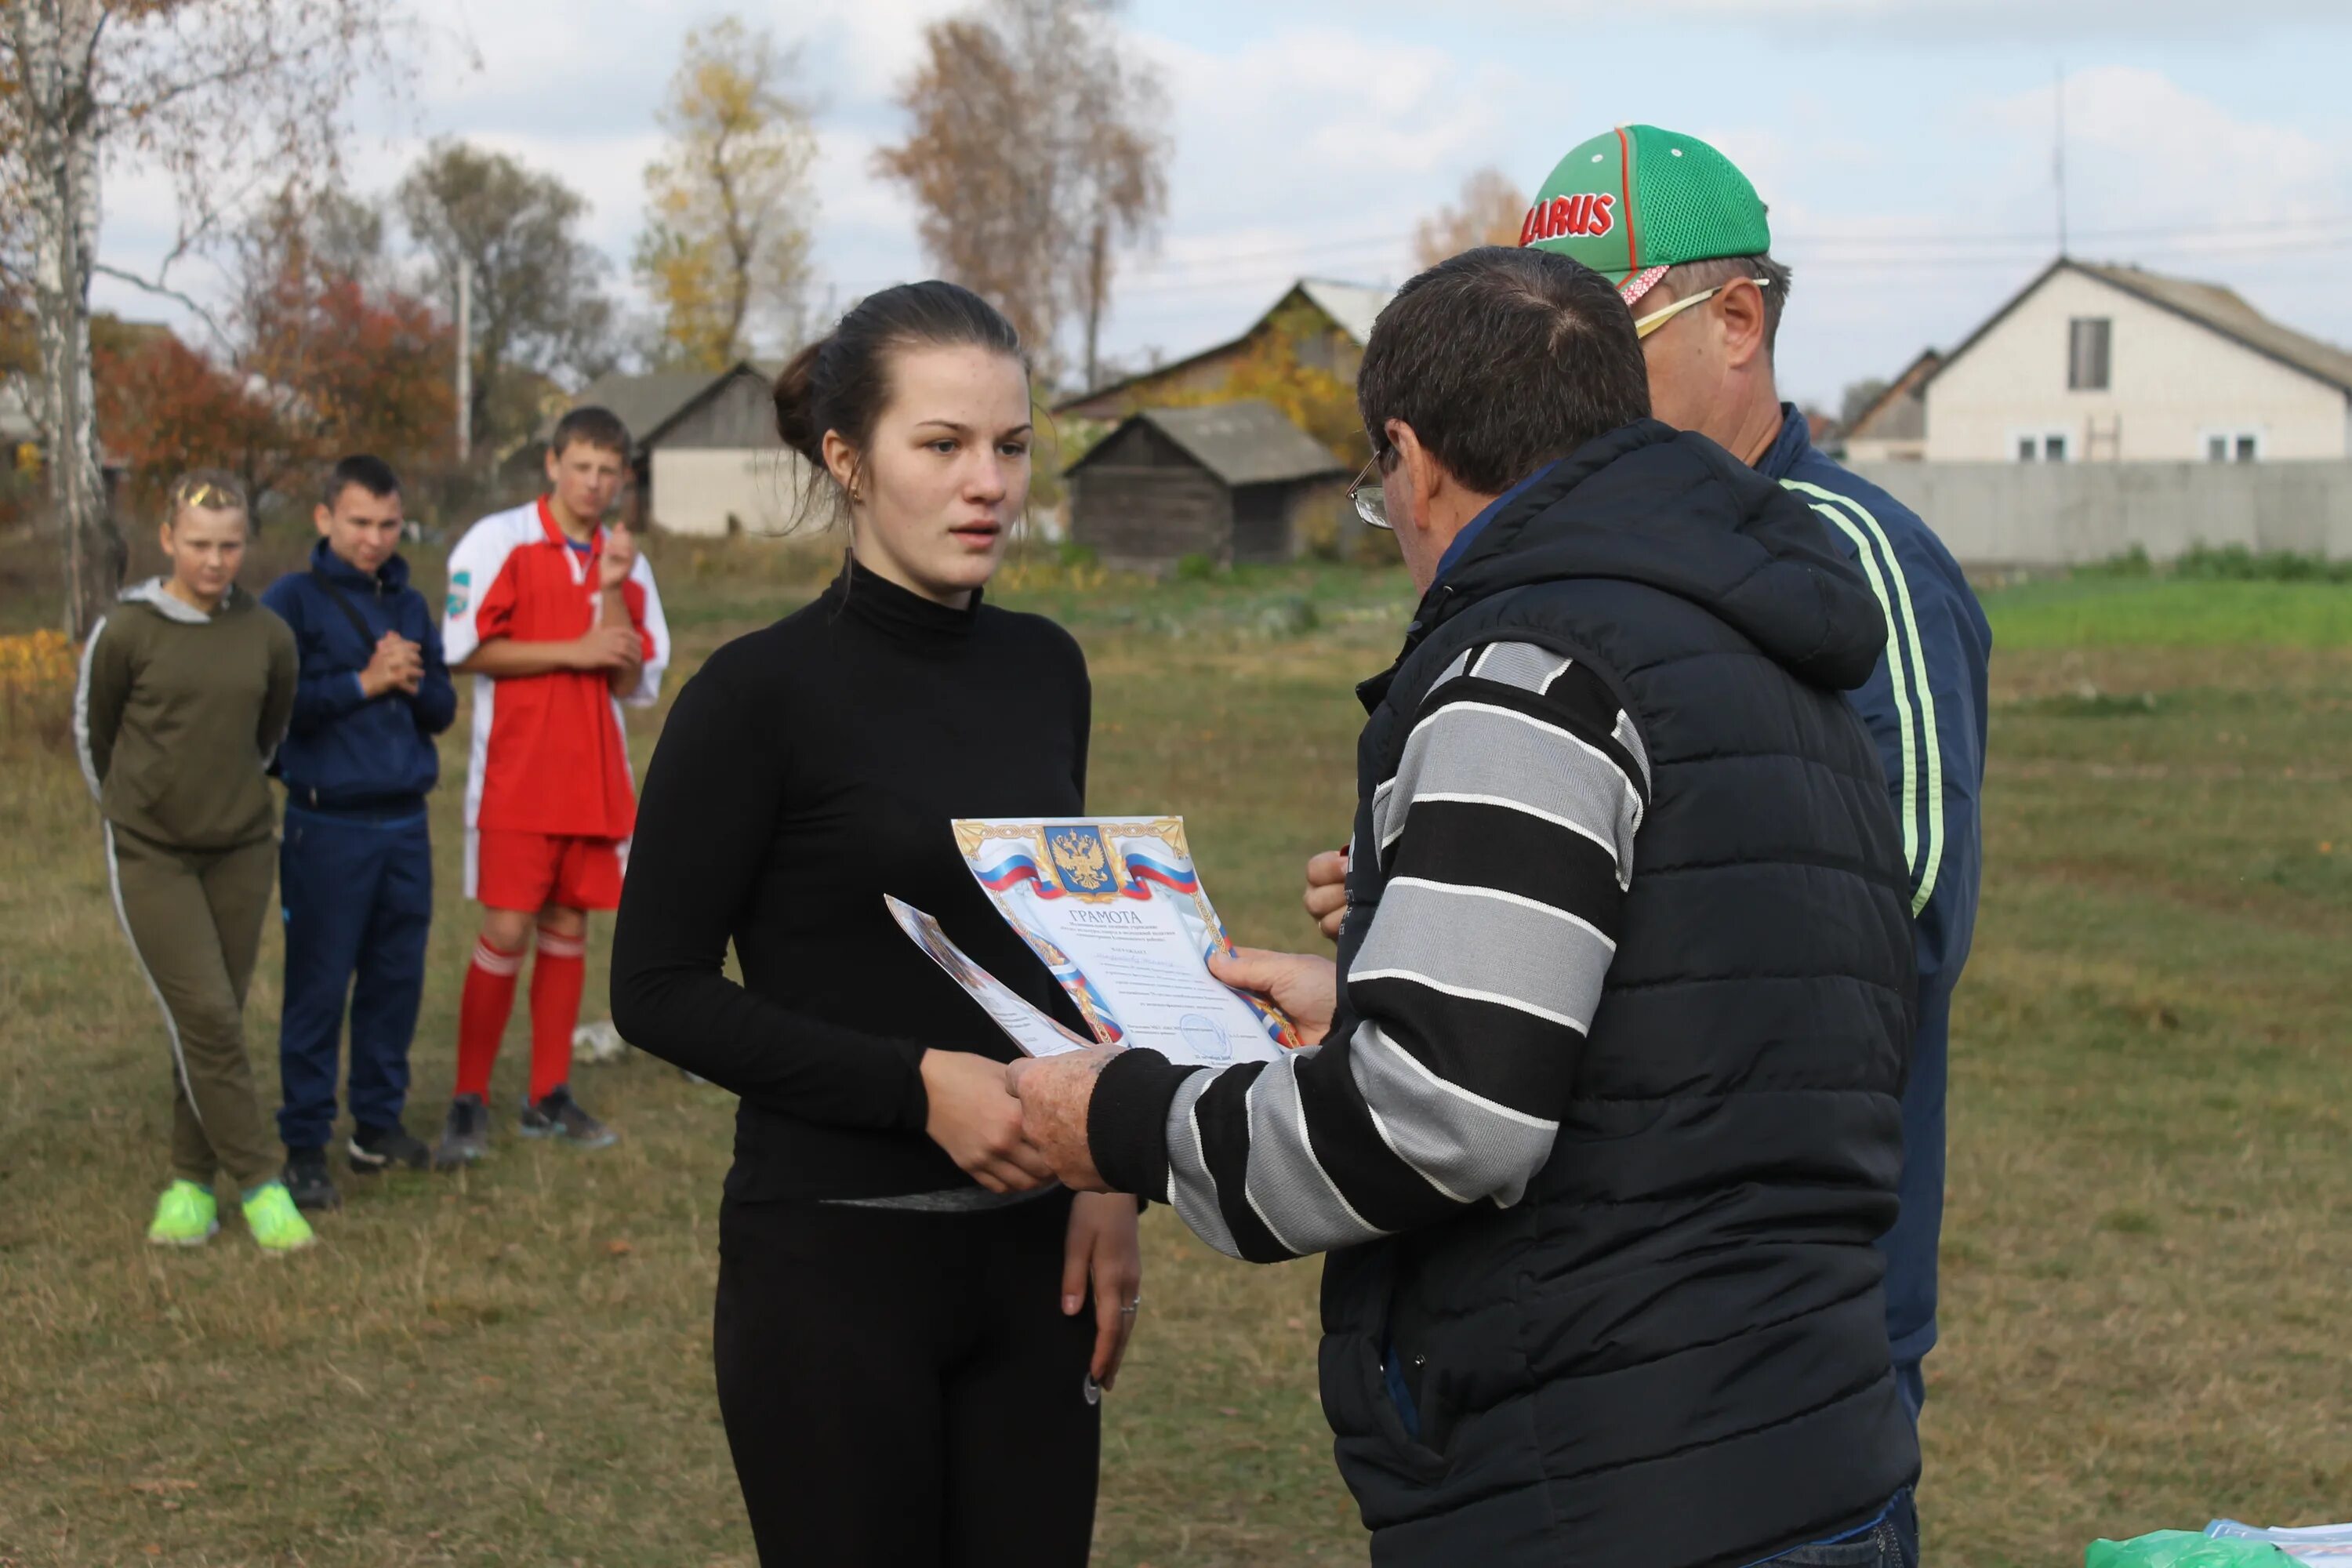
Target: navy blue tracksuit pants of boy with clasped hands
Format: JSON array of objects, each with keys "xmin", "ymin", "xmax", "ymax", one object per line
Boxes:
[{"xmin": 278, "ymin": 806, "xmax": 433, "ymax": 1149}]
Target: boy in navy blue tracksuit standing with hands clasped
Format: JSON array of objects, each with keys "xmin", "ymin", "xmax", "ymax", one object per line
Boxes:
[{"xmin": 261, "ymin": 456, "xmax": 456, "ymax": 1208}]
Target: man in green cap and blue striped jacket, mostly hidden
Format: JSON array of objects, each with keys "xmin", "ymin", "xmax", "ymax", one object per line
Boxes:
[{"xmin": 1308, "ymin": 125, "xmax": 1992, "ymax": 1542}]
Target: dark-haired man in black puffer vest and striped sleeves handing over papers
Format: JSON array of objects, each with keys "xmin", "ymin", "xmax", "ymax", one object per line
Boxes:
[{"xmin": 1014, "ymin": 249, "xmax": 1919, "ymax": 1568}]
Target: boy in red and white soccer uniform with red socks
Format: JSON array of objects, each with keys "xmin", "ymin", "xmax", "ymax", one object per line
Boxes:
[{"xmin": 433, "ymin": 409, "xmax": 670, "ymax": 1171}]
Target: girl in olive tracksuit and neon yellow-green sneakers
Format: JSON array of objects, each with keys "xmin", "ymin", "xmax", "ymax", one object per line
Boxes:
[{"xmin": 73, "ymin": 473, "xmax": 313, "ymax": 1253}]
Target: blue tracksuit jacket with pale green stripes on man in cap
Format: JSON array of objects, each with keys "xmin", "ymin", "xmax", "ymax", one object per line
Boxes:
[{"xmin": 1757, "ymin": 405, "xmax": 1992, "ymax": 1399}]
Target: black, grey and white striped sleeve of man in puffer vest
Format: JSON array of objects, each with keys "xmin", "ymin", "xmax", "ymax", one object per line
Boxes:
[{"xmin": 1091, "ymin": 642, "xmax": 1649, "ymax": 1260}]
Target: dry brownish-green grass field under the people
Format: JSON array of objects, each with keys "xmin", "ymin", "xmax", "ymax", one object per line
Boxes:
[{"xmin": 0, "ymin": 541, "xmax": 2352, "ymax": 1568}]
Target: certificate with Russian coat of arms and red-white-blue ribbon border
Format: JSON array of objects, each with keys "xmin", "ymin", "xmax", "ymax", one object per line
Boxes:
[{"xmin": 936, "ymin": 815, "xmax": 1301, "ymax": 1067}]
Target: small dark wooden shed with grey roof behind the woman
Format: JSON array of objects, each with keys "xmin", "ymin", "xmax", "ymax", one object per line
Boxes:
[{"xmin": 1068, "ymin": 397, "xmax": 1348, "ymax": 572}]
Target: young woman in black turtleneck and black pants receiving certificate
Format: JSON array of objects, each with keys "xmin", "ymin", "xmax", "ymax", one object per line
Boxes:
[{"xmin": 612, "ymin": 282, "xmax": 1141, "ymax": 1568}]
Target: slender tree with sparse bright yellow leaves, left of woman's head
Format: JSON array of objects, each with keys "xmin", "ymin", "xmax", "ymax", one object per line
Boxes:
[{"xmin": 635, "ymin": 16, "xmax": 816, "ymax": 369}]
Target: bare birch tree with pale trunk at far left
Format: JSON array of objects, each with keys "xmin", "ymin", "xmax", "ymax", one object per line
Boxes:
[{"xmin": 0, "ymin": 0, "xmax": 390, "ymax": 635}]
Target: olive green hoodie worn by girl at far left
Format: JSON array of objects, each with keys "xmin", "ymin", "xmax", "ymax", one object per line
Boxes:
[{"xmin": 73, "ymin": 579, "xmax": 296, "ymax": 848}]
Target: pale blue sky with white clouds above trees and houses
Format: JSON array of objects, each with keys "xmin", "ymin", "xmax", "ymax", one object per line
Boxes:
[{"xmin": 99, "ymin": 0, "xmax": 2352, "ymax": 407}]
